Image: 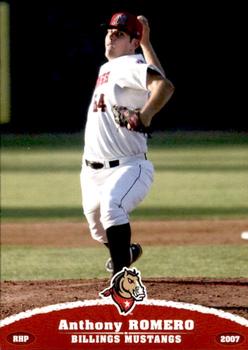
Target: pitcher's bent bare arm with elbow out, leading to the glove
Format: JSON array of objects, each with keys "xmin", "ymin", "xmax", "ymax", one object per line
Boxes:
[{"xmin": 140, "ymin": 70, "xmax": 175, "ymax": 127}]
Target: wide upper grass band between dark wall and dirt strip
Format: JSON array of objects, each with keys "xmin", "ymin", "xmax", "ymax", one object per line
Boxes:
[{"xmin": 1, "ymin": 133, "xmax": 248, "ymax": 221}]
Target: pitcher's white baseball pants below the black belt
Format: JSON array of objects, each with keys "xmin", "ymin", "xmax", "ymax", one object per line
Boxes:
[{"xmin": 80, "ymin": 158, "xmax": 154, "ymax": 243}]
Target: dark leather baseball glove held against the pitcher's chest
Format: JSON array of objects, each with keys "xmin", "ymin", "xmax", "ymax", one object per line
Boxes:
[{"xmin": 112, "ymin": 105, "xmax": 148, "ymax": 133}]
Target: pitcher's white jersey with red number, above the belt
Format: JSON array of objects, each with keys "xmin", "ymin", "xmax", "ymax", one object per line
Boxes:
[{"xmin": 84, "ymin": 54, "xmax": 162, "ymax": 161}]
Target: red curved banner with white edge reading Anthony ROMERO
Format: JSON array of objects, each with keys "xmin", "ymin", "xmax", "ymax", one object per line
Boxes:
[{"xmin": 1, "ymin": 299, "xmax": 248, "ymax": 350}]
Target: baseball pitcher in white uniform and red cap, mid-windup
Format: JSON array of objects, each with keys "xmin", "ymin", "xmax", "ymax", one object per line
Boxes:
[{"xmin": 80, "ymin": 12, "xmax": 174, "ymax": 275}]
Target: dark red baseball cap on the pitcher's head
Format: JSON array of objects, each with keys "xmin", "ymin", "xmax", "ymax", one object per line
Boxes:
[{"xmin": 105, "ymin": 12, "xmax": 142, "ymax": 40}]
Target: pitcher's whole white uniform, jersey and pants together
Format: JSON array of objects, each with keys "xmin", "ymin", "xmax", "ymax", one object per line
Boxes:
[{"xmin": 81, "ymin": 55, "xmax": 162, "ymax": 243}]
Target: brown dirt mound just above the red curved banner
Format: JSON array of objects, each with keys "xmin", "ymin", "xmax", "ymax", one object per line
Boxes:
[{"xmin": 1, "ymin": 278, "xmax": 248, "ymax": 318}]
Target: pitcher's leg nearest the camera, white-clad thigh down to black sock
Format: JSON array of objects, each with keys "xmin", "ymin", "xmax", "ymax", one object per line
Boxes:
[{"xmin": 101, "ymin": 161, "xmax": 153, "ymax": 273}]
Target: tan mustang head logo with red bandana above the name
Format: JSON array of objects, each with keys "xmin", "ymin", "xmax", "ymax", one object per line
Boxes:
[{"xmin": 99, "ymin": 267, "xmax": 146, "ymax": 315}]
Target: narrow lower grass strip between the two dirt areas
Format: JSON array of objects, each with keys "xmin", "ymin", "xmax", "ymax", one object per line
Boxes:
[{"xmin": 2, "ymin": 245, "xmax": 248, "ymax": 280}]
